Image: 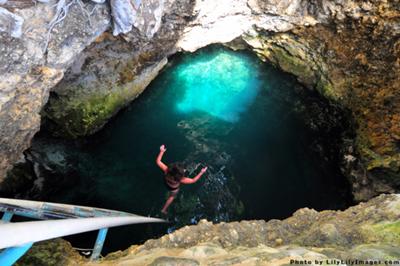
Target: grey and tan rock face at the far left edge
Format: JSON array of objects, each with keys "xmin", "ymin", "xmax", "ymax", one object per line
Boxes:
[{"xmin": 0, "ymin": 1, "xmax": 110, "ymax": 181}]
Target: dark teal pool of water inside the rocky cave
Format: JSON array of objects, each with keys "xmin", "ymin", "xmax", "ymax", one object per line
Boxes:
[{"xmin": 8, "ymin": 46, "xmax": 349, "ymax": 253}]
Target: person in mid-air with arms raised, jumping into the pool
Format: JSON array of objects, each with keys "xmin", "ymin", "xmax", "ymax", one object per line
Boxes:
[{"xmin": 156, "ymin": 145, "xmax": 207, "ymax": 214}]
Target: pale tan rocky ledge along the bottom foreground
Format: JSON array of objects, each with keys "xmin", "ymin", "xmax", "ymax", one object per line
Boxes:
[{"xmin": 20, "ymin": 194, "xmax": 400, "ymax": 266}]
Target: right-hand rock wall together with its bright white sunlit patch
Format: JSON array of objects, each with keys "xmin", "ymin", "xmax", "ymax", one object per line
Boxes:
[{"xmin": 178, "ymin": 0, "xmax": 400, "ymax": 201}]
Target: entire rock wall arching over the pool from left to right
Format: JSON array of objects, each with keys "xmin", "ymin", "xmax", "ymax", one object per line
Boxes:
[{"xmin": 0, "ymin": 0, "xmax": 400, "ymax": 201}]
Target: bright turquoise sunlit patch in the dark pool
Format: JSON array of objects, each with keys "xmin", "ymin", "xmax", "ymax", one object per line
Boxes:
[{"xmin": 175, "ymin": 50, "xmax": 260, "ymax": 123}]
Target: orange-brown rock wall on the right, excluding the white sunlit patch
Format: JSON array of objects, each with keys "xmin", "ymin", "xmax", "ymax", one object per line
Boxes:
[{"xmin": 244, "ymin": 1, "xmax": 400, "ymax": 201}]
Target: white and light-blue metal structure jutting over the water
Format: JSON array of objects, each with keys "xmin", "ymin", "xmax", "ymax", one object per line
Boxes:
[{"xmin": 0, "ymin": 198, "xmax": 165, "ymax": 266}]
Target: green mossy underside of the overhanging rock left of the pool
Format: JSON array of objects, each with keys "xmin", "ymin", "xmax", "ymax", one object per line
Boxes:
[{"xmin": 42, "ymin": 59, "xmax": 167, "ymax": 138}]
